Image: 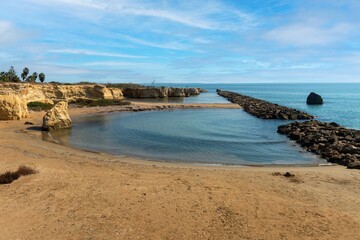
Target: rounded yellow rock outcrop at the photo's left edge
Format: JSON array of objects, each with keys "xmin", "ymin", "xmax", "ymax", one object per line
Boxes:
[{"xmin": 0, "ymin": 94, "xmax": 29, "ymax": 120}]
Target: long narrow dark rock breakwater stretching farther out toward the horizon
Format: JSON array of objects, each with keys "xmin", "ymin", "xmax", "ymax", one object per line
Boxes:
[{"xmin": 216, "ymin": 89, "xmax": 315, "ymax": 120}]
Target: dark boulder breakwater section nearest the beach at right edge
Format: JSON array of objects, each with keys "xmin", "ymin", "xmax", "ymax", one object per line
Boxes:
[{"xmin": 278, "ymin": 120, "xmax": 360, "ymax": 169}]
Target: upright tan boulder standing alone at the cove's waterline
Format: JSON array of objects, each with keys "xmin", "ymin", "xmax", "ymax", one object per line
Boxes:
[{"xmin": 42, "ymin": 101, "xmax": 71, "ymax": 131}]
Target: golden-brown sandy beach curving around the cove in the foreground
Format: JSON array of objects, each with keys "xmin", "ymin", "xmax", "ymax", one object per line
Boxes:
[{"xmin": 0, "ymin": 102, "xmax": 360, "ymax": 239}]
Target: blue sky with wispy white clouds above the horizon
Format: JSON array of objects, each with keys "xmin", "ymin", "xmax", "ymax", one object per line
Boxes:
[{"xmin": 0, "ymin": 0, "xmax": 360, "ymax": 83}]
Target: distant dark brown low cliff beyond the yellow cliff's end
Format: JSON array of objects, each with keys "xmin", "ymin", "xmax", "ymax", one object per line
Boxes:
[{"xmin": 122, "ymin": 87, "xmax": 204, "ymax": 98}]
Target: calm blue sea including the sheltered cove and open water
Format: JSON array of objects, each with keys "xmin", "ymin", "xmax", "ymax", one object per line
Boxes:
[{"xmin": 52, "ymin": 83, "xmax": 360, "ymax": 166}]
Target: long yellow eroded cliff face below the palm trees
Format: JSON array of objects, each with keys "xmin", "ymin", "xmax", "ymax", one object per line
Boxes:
[{"xmin": 0, "ymin": 83, "xmax": 123, "ymax": 103}]
